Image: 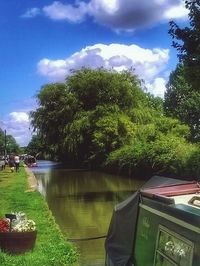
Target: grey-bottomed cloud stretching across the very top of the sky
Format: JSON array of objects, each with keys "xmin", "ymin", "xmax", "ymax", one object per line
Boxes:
[{"xmin": 22, "ymin": 0, "xmax": 188, "ymax": 31}]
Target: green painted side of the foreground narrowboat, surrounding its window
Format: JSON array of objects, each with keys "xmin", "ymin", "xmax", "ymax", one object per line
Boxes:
[{"xmin": 132, "ymin": 204, "xmax": 200, "ymax": 266}]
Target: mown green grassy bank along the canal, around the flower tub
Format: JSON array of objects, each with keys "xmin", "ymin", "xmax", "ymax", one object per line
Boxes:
[{"xmin": 0, "ymin": 167, "xmax": 78, "ymax": 266}]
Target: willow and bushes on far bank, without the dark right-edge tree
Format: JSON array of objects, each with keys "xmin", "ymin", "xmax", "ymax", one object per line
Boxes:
[{"xmin": 29, "ymin": 68, "xmax": 197, "ymax": 179}]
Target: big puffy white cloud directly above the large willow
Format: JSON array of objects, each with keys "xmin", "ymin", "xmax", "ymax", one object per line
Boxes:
[{"xmin": 37, "ymin": 44, "xmax": 169, "ymax": 94}]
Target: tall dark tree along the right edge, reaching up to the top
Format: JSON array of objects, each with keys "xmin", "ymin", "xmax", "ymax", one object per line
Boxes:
[{"xmin": 164, "ymin": 0, "xmax": 200, "ymax": 142}]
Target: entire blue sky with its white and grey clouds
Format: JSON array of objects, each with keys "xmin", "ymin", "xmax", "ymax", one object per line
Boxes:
[{"xmin": 0, "ymin": 0, "xmax": 188, "ymax": 146}]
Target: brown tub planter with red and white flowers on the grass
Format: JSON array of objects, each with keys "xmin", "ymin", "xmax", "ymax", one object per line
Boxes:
[{"xmin": 0, "ymin": 212, "xmax": 37, "ymax": 254}]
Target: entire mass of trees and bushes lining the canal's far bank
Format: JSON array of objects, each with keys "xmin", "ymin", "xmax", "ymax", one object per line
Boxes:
[{"xmin": 28, "ymin": 1, "xmax": 200, "ymax": 178}]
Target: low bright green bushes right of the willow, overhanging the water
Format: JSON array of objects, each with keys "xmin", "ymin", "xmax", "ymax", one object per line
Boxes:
[{"xmin": 106, "ymin": 125, "xmax": 200, "ymax": 179}]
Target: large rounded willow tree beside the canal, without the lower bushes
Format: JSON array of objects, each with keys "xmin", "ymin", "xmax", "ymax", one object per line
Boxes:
[{"xmin": 31, "ymin": 68, "xmax": 148, "ymax": 163}]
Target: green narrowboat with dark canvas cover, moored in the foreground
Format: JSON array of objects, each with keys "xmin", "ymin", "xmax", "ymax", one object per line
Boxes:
[{"xmin": 105, "ymin": 176, "xmax": 200, "ymax": 266}]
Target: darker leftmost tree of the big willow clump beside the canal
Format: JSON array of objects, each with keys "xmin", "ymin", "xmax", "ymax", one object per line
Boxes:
[{"xmin": 31, "ymin": 83, "xmax": 78, "ymax": 161}]
